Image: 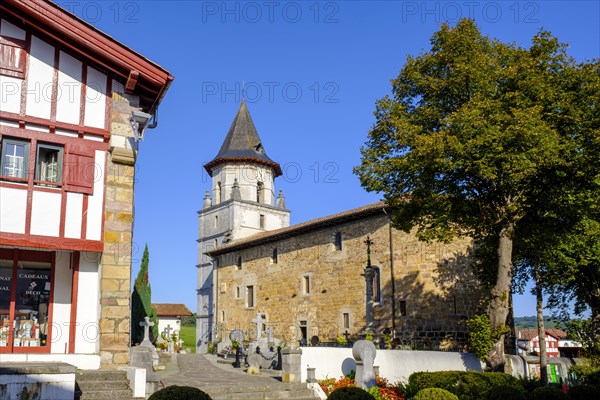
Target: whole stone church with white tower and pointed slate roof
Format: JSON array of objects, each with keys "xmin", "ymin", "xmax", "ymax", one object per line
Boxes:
[{"xmin": 197, "ymin": 101, "xmax": 487, "ymax": 352}]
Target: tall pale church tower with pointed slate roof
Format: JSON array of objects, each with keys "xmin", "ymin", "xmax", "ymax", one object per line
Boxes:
[{"xmin": 196, "ymin": 101, "xmax": 290, "ymax": 352}]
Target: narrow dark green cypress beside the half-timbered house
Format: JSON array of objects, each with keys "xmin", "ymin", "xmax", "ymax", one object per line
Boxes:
[{"xmin": 131, "ymin": 244, "xmax": 158, "ymax": 344}]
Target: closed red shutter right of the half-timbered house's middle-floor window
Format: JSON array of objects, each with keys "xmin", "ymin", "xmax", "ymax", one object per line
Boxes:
[{"xmin": 63, "ymin": 145, "xmax": 99, "ymax": 194}]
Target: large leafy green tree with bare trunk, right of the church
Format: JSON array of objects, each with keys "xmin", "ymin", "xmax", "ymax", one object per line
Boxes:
[{"xmin": 355, "ymin": 19, "xmax": 596, "ymax": 370}]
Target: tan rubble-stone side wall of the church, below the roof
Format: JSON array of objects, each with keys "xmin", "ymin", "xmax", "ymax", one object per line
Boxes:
[{"xmin": 216, "ymin": 212, "xmax": 484, "ymax": 348}]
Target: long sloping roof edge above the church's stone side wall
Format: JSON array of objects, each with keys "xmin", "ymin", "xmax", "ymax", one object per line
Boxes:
[{"xmin": 206, "ymin": 201, "xmax": 389, "ymax": 257}]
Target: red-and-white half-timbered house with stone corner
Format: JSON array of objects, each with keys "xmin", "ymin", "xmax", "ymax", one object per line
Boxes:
[{"xmin": 0, "ymin": 0, "xmax": 173, "ymax": 368}]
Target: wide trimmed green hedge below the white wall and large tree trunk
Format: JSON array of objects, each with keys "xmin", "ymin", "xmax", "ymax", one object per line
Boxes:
[{"xmin": 408, "ymin": 371, "xmax": 521, "ymax": 400}]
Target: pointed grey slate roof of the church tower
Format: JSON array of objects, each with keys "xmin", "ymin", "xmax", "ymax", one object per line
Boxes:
[{"xmin": 204, "ymin": 100, "xmax": 281, "ymax": 177}]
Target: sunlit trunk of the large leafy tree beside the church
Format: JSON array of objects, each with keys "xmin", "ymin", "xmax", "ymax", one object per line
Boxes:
[{"xmin": 485, "ymin": 224, "xmax": 514, "ymax": 372}]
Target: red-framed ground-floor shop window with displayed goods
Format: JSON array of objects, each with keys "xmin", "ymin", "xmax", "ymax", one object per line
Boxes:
[{"xmin": 0, "ymin": 249, "xmax": 54, "ymax": 353}]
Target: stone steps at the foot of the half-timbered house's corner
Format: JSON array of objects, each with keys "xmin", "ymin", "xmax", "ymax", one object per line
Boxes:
[{"xmin": 75, "ymin": 370, "xmax": 134, "ymax": 400}]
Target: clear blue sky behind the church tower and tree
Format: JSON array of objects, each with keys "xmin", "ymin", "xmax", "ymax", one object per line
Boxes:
[{"xmin": 62, "ymin": 0, "xmax": 600, "ymax": 316}]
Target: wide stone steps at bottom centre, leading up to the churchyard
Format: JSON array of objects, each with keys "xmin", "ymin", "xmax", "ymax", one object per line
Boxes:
[{"xmin": 200, "ymin": 381, "xmax": 318, "ymax": 400}]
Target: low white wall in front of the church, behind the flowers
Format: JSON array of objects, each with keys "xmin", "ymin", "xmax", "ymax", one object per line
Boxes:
[{"xmin": 301, "ymin": 347, "xmax": 483, "ymax": 383}]
